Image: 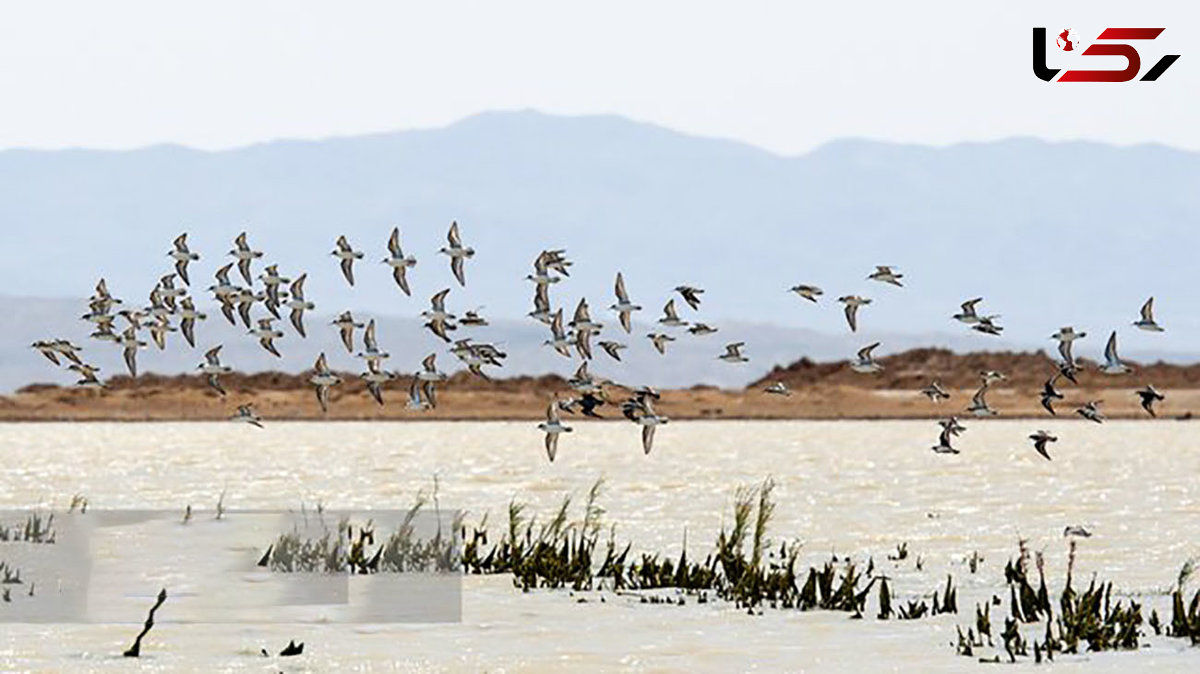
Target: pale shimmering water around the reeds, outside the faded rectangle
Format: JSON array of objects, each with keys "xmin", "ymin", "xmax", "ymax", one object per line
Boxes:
[{"xmin": 0, "ymin": 421, "xmax": 1200, "ymax": 672}]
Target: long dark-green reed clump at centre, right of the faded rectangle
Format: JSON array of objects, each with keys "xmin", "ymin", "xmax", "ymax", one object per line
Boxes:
[{"xmin": 462, "ymin": 479, "xmax": 958, "ymax": 620}]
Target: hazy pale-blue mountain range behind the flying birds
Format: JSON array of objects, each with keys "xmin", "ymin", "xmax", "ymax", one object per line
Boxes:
[{"xmin": 0, "ymin": 112, "xmax": 1200, "ymax": 389}]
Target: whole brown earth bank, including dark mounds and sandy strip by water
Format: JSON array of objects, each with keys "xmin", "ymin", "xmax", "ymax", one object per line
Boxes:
[{"xmin": 0, "ymin": 349, "xmax": 1200, "ymax": 421}]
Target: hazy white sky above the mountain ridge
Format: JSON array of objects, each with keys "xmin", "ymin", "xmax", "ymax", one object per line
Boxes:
[{"xmin": 0, "ymin": 0, "xmax": 1200, "ymax": 154}]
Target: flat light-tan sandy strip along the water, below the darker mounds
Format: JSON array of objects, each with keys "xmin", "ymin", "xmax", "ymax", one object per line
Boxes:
[{"xmin": 0, "ymin": 385, "xmax": 1200, "ymax": 421}]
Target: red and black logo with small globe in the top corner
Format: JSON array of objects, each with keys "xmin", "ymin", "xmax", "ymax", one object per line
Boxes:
[{"xmin": 1033, "ymin": 28, "xmax": 1180, "ymax": 82}]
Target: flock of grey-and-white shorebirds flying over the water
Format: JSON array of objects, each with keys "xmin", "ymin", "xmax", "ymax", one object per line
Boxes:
[{"xmin": 32, "ymin": 230, "xmax": 1164, "ymax": 462}]
